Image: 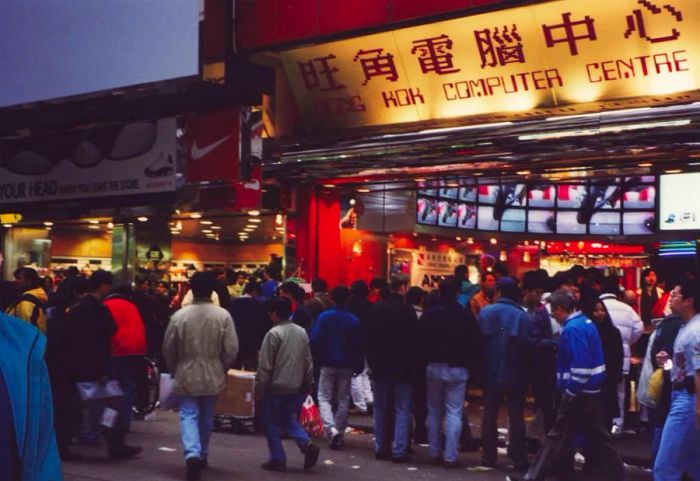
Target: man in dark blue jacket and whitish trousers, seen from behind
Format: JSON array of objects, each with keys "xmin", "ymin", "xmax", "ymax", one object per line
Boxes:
[{"xmin": 310, "ymin": 286, "xmax": 365, "ymax": 449}]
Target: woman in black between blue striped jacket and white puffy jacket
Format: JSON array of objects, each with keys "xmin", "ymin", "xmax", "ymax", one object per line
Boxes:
[{"xmin": 581, "ymin": 296, "xmax": 624, "ymax": 429}]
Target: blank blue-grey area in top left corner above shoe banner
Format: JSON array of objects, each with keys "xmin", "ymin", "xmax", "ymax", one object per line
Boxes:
[{"xmin": 0, "ymin": 0, "xmax": 200, "ymax": 107}]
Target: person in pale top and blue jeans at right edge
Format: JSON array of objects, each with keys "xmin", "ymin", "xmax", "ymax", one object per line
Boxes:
[{"xmin": 654, "ymin": 280, "xmax": 700, "ymax": 481}]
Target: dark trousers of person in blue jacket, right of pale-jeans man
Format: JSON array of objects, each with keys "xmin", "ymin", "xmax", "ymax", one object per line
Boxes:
[{"xmin": 481, "ymin": 386, "xmax": 527, "ymax": 466}]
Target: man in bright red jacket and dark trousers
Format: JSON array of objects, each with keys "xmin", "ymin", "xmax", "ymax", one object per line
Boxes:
[{"xmin": 104, "ymin": 288, "xmax": 146, "ymax": 451}]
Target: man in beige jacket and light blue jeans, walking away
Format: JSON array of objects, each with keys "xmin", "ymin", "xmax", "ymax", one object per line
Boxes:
[{"xmin": 163, "ymin": 272, "xmax": 238, "ymax": 481}]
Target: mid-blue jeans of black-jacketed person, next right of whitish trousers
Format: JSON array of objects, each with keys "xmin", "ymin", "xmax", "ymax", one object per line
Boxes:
[{"xmin": 374, "ymin": 381, "xmax": 413, "ymax": 458}]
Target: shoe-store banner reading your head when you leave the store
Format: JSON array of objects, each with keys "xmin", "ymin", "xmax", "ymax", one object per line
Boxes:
[{"xmin": 0, "ymin": 118, "xmax": 177, "ymax": 206}]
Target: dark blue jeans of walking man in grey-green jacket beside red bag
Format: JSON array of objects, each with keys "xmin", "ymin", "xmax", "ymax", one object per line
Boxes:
[{"xmin": 262, "ymin": 393, "xmax": 311, "ymax": 463}]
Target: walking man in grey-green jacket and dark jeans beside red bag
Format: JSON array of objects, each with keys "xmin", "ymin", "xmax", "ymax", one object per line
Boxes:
[{"xmin": 255, "ymin": 298, "xmax": 320, "ymax": 471}]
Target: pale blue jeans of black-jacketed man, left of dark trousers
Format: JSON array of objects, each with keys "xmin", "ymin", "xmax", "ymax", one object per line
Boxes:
[{"xmin": 425, "ymin": 362, "xmax": 469, "ymax": 462}]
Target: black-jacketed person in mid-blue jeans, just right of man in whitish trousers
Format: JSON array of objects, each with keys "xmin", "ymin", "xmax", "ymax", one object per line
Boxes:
[{"xmin": 363, "ymin": 279, "xmax": 418, "ymax": 463}]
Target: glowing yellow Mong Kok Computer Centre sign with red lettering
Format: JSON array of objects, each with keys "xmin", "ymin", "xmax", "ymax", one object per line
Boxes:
[{"xmin": 282, "ymin": 0, "xmax": 700, "ymax": 127}]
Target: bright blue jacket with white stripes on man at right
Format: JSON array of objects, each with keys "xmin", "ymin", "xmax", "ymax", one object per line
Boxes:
[{"xmin": 557, "ymin": 312, "xmax": 605, "ymax": 396}]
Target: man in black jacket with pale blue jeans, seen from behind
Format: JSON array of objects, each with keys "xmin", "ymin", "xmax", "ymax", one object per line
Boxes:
[{"xmin": 419, "ymin": 281, "xmax": 481, "ymax": 467}]
